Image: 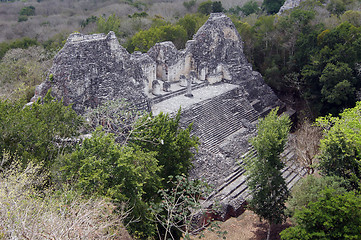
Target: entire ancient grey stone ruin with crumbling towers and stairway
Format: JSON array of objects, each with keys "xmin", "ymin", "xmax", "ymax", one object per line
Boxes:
[{"xmin": 33, "ymin": 13, "xmax": 300, "ymax": 220}]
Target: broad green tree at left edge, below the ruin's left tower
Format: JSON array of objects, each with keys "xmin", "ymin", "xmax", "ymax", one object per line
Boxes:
[{"xmin": 0, "ymin": 91, "xmax": 83, "ymax": 168}]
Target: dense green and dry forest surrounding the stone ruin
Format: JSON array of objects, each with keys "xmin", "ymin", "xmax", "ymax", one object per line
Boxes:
[{"xmin": 0, "ymin": 0, "xmax": 361, "ymax": 239}]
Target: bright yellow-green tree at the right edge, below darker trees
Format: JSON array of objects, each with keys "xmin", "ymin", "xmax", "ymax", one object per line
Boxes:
[{"xmin": 317, "ymin": 102, "xmax": 361, "ymax": 189}]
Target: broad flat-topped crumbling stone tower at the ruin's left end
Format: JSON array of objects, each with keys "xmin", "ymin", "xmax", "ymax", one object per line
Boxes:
[{"xmin": 33, "ymin": 32, "xmax": 146, "ymax": 113}]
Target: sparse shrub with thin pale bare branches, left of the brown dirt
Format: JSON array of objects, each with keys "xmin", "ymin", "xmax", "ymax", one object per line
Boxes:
[{"xmin": 150, "ymin": 176, "xmax": 213, "ymax": 240}]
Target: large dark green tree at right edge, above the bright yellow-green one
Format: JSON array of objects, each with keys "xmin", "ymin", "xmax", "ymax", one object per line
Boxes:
[{"xmin": 297, "ymin": 22, "xmax": 361, "ymax": 115}]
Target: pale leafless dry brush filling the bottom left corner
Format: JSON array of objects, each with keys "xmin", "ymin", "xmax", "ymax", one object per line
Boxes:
[{"xmin": 0, "ymin": 158, "xmax": 128, "ymax": 239}]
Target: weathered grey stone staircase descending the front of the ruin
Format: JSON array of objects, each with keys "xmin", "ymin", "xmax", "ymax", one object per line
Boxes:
[{"xmin": 170, "ymin": 83, "xmax": 306, "ymax": 225}]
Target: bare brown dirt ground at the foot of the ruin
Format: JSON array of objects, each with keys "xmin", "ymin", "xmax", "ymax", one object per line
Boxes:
[{"xmin": 188, "ymin": 210, "xmax": 291, "ymax": 240}]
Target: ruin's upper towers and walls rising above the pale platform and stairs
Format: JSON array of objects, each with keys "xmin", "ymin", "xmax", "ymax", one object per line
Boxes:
[{"xmin": 33, "ymin": 13, "xmax": 280, "ymax": 113}]
